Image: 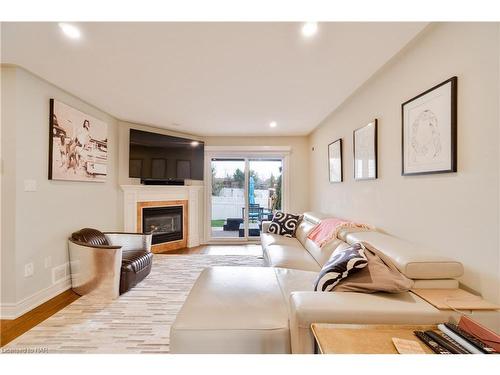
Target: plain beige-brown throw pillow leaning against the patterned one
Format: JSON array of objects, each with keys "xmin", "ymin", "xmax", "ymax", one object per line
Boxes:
[{"xmin": 333, "ymin": 248, "xmax": 413, "ymax": 293}]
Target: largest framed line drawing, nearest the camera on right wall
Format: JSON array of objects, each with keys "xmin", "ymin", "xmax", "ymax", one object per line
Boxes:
[{"xmin": 401, "ymin": 77, "xmax": 457, "ymax": 176}]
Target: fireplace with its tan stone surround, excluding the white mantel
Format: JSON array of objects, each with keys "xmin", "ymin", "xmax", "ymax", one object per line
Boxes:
[{"xmin": 136, "ymin": 200, "xmax": 188, "ymax": 253}]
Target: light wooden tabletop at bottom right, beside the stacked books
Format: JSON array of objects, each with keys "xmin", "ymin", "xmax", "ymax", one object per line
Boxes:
[{"xmin": 311, "ymin": 323, "xmax": 437, "ymax": 354}]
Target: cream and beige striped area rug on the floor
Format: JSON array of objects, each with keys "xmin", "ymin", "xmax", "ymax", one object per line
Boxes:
[{"xmin": 2, "ymin": 254, "xmax": 264, "ymax": 353}]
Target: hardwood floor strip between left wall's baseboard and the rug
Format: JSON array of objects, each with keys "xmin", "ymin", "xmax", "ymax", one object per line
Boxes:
[{"xmin": 0, "ymin": 289, "xmax": 80, "ymax": 347}]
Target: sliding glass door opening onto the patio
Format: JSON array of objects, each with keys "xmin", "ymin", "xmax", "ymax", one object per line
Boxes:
[{"xmin": 209, "ymin": 157, "xmax": 283, "ymax": 241}]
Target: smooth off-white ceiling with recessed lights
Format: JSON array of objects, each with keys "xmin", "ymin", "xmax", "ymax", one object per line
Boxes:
[{"xmin": 1, "ymin": 22, "xmax": 427, "ymax": 135}]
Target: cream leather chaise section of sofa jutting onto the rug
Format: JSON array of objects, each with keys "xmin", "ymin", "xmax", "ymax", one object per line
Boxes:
[{"xmin": 170, "ymin": 267, "xmax": 290, "ymax": 353}]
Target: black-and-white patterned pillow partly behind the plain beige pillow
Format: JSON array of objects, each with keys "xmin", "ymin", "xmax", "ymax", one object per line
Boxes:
[{"xmin": 314, "ymin": 243, "xmax": 368, "ymax": 292}]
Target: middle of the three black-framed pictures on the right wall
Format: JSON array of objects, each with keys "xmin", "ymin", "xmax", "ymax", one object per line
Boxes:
[{"xmin": 353, "ymin": 119, "xmax": 377, "ymax": 180}]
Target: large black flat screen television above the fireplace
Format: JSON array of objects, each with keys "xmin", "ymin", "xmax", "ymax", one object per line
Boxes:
[{"xmin": 129, "ymin": 129, "xmax": 205, "ymax": 181}]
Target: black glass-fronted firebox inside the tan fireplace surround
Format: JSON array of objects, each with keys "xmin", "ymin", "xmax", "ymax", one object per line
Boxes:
[{"xmin": 142, "ymin": 206, "xmax": 183, "ymax": 245}]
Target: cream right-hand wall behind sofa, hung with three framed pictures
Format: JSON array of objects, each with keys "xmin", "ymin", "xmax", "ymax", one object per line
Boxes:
[{"xmin": 310, "ymin": 23, "xmax": 500, "ymax": 301}]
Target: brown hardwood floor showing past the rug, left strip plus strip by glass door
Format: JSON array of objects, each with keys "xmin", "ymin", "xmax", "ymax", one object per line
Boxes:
[{"xmin": 0, "ymin": 244, "xmax": 262, "ymax": 347}]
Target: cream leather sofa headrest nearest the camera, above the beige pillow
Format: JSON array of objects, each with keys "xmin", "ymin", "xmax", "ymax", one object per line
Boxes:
[{"xmin": 347, "ymin": 231, "xmax": 463, "ymax": 279}]
